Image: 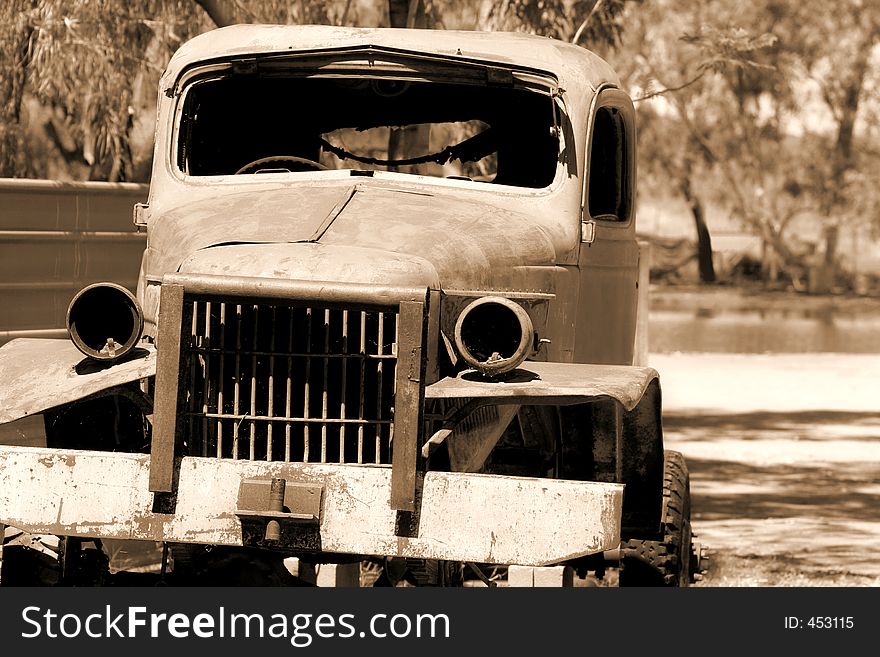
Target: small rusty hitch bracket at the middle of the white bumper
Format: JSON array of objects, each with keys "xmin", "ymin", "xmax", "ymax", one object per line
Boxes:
[{"xmin": 235, "ymin": 478, "xmax": 324, "ymax": 550}]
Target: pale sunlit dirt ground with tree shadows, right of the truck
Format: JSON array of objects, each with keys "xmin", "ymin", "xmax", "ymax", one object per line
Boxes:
[{"xmin": 649, "ymin": 353, "xmax": 880, "ymax": 587}]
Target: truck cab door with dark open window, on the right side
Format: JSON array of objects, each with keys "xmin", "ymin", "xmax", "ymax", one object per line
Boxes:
[{"xmin": 574, "ymin": 89, "xmax": 639, "ymax": 365}]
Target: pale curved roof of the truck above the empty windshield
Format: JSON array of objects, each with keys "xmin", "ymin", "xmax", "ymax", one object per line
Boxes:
[{"xmin": 163, "ymin": 24, "xmax": 619, "ymax": 96}]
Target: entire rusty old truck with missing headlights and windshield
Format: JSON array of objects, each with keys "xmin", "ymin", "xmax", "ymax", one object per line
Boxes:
[{"xmin": 0, "ymin": 25, "xmax": 701, "ymax": 586}]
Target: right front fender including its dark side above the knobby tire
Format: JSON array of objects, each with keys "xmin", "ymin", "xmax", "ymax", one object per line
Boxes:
[{"xmin": 422, "ymin": 361, "xmax": 663, "ymax": 536}]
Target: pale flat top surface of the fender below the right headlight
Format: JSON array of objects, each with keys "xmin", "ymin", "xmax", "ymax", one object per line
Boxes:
[{"xmin": 425, "ymin": 361, "xmax": 658, "ymax": 411}]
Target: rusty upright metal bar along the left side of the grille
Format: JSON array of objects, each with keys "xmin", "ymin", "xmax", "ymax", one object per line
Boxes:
[{"xmin": 150, "ymin": 283, "xmax": 186, "ymax": 493}]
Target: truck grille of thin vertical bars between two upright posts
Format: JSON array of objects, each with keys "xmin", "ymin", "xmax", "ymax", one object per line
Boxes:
[{"xmin": 179, "ymin": 297, "xmax": 398, "ymax": 464}]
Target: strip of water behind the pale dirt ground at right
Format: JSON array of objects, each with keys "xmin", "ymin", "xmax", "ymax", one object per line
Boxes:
[{"xmin": 648, "ymin": 309, "xmax": 880, "ymax": 354}]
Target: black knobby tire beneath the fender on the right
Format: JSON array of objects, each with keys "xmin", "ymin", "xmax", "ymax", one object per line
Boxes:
[{"xmin": 619, "ymin": 450, "xmax": 692, "ymax": 587}]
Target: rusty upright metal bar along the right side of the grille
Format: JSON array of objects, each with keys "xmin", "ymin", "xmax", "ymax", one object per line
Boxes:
[{"xmin": 391, "ymin": 301, "xmax": 427, "ymax": 511}]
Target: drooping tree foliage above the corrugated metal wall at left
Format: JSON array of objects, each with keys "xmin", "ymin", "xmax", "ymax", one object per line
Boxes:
[{"xmin": 0, "ymin": 0, "xmax": 209, "ymax": 181}]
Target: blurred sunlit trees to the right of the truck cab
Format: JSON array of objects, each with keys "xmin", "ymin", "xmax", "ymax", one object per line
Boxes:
[{"xmin": 618, "ymin": 0, "xmax": 880, "ymax": 291}]
